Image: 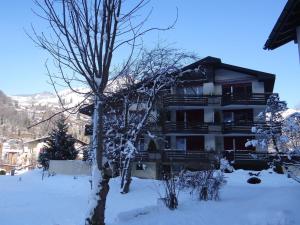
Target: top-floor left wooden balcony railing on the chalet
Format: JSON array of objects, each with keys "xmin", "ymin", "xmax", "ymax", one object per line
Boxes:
[{"xmin": 163, "ymin": 94, "xmax": 208, "ymax": 106}]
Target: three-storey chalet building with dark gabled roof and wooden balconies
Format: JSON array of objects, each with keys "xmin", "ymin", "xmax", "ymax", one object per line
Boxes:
[{"xmin": 81, "ymin": 57, "xmax": 275, "ymax": 178}]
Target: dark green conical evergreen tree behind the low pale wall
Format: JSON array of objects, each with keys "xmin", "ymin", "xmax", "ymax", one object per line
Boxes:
[{"xmin": 39, "ymin": 117, "xmax": 78, "ymax": 169}]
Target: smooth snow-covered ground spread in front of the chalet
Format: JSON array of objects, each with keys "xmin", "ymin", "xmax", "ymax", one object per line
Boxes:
[{"xmin": 0, "ymin": 170, "xmax": 300, "ymax": 225}]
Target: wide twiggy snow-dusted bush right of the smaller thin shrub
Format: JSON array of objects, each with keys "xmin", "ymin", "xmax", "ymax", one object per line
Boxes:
[{"xmin": 178, "ymin": 170, "xmax": 226, "ymax": 201}]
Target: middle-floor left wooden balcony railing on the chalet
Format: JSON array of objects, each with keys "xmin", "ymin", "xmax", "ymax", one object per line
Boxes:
[{"xmin": 164, "ymin": 121, "xmax": 208, "ymax": 133}]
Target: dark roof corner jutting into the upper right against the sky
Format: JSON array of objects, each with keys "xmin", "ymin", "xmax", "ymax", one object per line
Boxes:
[{"xmin": 264, "ymin": 0, "xmax": 300, "ymax": 50}]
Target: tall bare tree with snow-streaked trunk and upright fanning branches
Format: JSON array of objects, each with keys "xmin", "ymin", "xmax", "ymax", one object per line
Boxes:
[{"xmin": 33, "ymin": 0, "xmax": 178, "ymax": 224}]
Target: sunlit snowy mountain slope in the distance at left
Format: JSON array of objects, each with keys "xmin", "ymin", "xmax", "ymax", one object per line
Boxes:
[{"xmin": 0, "ymin": 88, "xmax": 89, "ymax": 141}]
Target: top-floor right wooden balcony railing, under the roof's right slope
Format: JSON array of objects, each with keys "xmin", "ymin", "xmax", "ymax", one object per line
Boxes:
[{"xmin": 221, "ymin": 93, "xmax": 270, "ymax": 106}]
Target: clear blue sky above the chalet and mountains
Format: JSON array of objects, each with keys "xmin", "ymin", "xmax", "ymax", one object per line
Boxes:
[{"xmin": 0, "ymin": 0, "xmax": 300, "ymax": 108}]
